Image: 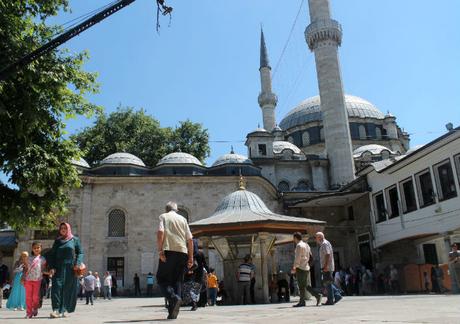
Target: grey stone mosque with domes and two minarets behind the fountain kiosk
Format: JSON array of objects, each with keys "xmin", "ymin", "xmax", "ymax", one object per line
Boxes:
[{"xmin": 10, "ymin": 0, "xmax": 416, "ymax": 290}]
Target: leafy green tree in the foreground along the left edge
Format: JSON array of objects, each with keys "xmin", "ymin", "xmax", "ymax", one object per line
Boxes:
[{"xmin": 0, "ymin": 0, "xmax": 99, "ymax": 228}]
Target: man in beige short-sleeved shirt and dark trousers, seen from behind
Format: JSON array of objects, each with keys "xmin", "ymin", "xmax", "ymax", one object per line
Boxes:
[{"xmin": 157, "ymin": 202, "xmax": 193, "ymax": 319}]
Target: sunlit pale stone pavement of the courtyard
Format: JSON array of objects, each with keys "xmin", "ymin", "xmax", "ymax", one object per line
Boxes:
[{"xmin": 0, "ymin": 295, "xmax": 460, "ymax": 324}]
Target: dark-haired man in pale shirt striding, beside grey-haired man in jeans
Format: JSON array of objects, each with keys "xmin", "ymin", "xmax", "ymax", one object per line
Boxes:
[{"xmin": 291, "ymin": 232, "xmax": 321, "ymax": 307}]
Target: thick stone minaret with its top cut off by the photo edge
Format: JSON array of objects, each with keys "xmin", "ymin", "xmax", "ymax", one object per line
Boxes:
[{"xmin": 305, "ymin": 0, "xmax": 355, "ymax": 187}]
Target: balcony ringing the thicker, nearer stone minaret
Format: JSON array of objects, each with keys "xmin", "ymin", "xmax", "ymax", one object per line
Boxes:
[{"xmin": 305, "ymin": 19, "xmax": 342, "ymax": 50}]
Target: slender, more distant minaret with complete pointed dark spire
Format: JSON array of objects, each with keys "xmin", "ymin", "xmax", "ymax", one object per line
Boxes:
[{"xmin": 258, "ymin": 29, "xmax": 278, "ymax": 132}]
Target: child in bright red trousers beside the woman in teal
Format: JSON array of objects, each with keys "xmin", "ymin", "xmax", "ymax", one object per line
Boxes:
[{"xmin": 24, "ymin": 242, "xmax": 46, "ymax": 318}]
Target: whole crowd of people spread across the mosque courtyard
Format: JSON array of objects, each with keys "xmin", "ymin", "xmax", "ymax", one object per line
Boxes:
[{"xmin": 0, "ymin": 202, "xmax": 460, "ymax": 319}]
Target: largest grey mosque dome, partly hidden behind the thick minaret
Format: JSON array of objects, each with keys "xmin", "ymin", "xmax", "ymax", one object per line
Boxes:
[{"xmin": 280, "ymin": 95, "xmax": 385, "ymax": 130}]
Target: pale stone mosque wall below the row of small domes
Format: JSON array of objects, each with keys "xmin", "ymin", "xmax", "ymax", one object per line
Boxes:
[{"xmin": 64, "ymin": 176, "xmax": 282, "ymax": 289}]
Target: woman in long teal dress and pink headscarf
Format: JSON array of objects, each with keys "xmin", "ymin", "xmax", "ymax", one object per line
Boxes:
[{"xmin": 45, "ymin": 223, "xmax": 84, "ymax": 318}]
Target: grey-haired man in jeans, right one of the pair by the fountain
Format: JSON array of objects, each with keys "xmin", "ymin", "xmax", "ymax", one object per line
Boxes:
[{"xmin": 315, "ymin": 232, "xmax": 342, "ymax": 305}]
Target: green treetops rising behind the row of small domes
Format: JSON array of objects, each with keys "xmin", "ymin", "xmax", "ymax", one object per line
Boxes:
[{"xmin": 73, "ymin": 107, "xmax": 210, "ymax": 167}]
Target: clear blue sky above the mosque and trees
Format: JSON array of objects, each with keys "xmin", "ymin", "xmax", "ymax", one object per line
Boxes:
[{"xmin": 48, "ymin": 0, "xmax": 460, "ymax": 164}]
